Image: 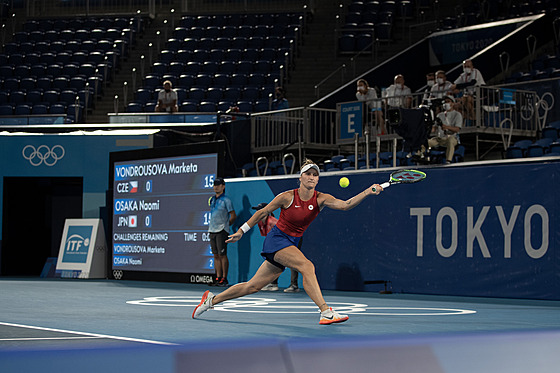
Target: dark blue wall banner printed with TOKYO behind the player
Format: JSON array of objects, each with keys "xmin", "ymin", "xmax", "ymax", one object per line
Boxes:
[{"xmin": 228, "ymin": 162, "xmax": 560, "ymax": 299}]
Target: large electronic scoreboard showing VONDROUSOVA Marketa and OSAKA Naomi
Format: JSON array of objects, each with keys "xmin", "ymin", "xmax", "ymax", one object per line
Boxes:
[{"xmin": 110, "ymin": 144, "xmax": 223, "ymax": 274}]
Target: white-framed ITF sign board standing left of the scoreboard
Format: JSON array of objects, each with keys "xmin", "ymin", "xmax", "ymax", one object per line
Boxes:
[{"xmin": 56, "ymin": 219, "xmax": 107, "ymax": 278}]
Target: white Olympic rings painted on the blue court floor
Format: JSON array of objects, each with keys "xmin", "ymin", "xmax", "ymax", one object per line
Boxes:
[{"xmin": 126, "ymin": 296, "xmax": 476, "ymax": 316}]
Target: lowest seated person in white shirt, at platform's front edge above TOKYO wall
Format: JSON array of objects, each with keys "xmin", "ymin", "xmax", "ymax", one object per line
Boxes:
[{"xmin": 428, "ymin": 96, "xmax": 463, "ymax": 163}]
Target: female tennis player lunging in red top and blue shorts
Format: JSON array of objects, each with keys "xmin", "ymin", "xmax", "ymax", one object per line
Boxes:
[{"xmin": 192, "ymin": 159, "xmax": 383, "ymax": 325}]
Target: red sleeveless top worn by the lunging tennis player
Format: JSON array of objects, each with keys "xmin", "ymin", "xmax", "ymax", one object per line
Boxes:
[{"xmin": 276, "ymin": 189, "xmax": 319, "ymax": 237}]
